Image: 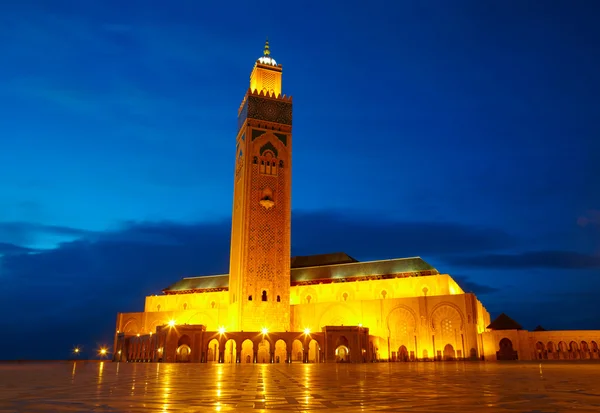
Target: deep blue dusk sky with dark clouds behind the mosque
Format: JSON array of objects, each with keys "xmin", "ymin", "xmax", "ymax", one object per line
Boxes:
[{"xmin": 0, "ymin": 0, "xmax": 600, "ymax": 359}]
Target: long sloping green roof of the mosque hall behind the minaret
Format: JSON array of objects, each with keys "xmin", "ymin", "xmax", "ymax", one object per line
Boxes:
[{"xmin": 163, "ymin": 253, "xmax": 439, "ymax": 294}]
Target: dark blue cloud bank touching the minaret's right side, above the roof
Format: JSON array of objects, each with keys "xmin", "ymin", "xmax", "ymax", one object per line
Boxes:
[{"xmin": 292, "ymin": 211, "xmax": 520, "ymax": 259}]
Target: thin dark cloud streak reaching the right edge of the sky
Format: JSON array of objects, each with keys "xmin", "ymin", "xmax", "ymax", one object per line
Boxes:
[{"xmin": 445, "ymin": 251, "xmax": 600, "ymax": 270}]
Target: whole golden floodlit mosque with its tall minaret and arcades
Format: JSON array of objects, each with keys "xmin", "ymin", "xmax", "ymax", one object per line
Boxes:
[{"xmin": 113, "ymin": 42, "xmax": 600, "ymax": 363}]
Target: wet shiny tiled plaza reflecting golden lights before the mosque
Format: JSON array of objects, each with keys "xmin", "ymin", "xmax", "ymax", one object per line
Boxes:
[{"xmin": 0, "ymin": 361, "xmax": 600, "ymax": 413}]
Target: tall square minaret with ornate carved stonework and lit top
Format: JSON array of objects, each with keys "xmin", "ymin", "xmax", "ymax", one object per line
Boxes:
[{"xmin": 227, "ymin": 40, "xmax": 292, "ymax": 331}]
